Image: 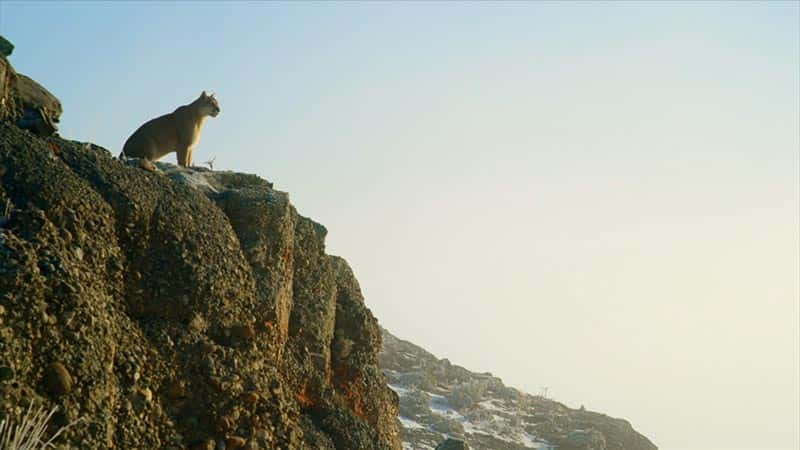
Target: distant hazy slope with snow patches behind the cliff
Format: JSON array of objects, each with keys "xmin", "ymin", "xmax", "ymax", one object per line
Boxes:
[{"xmin": 380, "ymin": 330, "xmax": 657, "ymax": 450}]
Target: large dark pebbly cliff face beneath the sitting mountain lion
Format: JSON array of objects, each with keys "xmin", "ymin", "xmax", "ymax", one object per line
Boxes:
[{"xmin": 0, "ymin": 121, "xmax": 400, "ymax": 449}]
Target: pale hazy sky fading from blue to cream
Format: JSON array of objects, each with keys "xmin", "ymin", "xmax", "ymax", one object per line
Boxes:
[{"xmin": 0, "ymin": 1, "xmax": 800, "ymax": 450}]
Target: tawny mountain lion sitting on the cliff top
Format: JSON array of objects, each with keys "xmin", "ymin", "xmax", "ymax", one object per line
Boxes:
[{"xmin": 119, "ymin": 91, "xmax": 220, "ymax": 170}]
